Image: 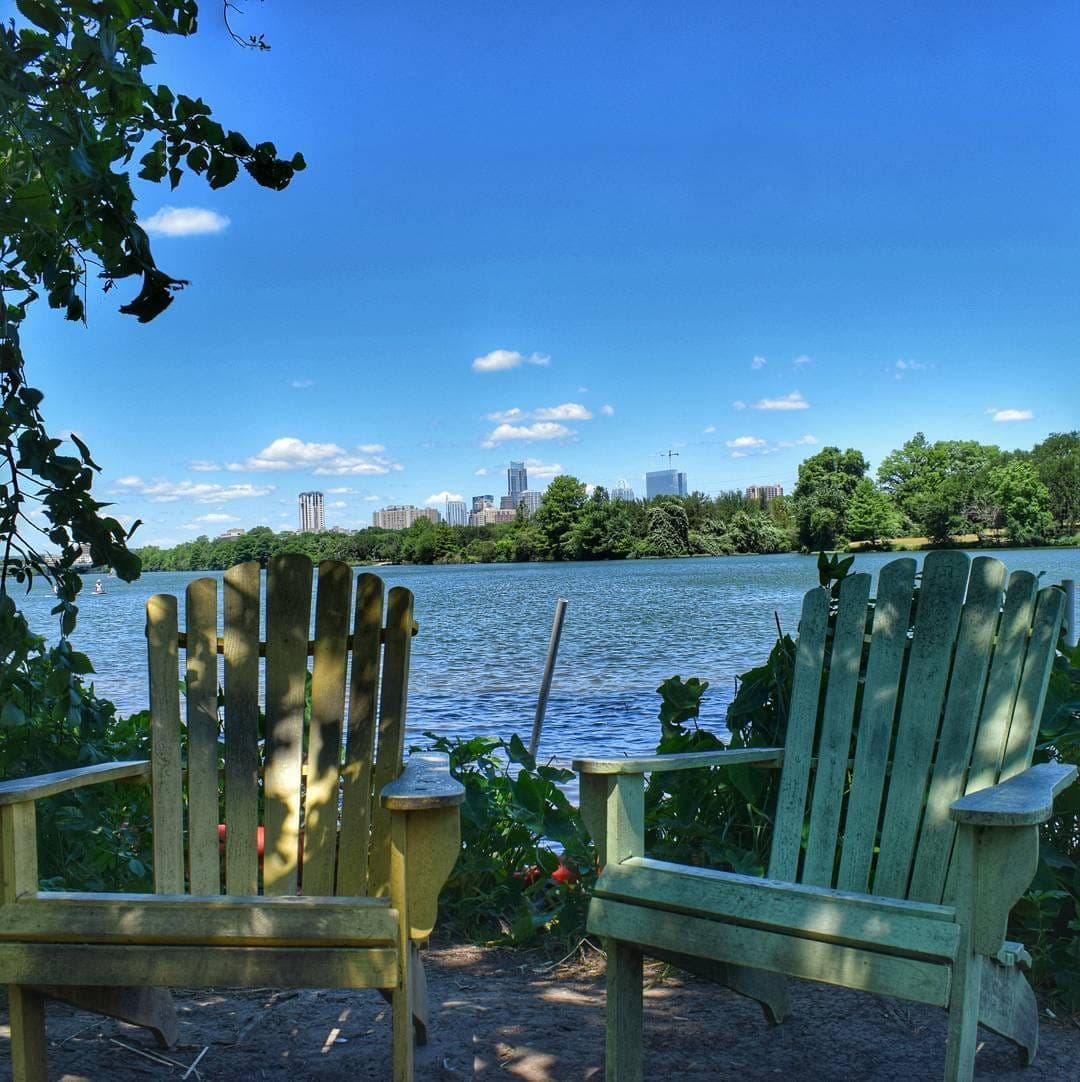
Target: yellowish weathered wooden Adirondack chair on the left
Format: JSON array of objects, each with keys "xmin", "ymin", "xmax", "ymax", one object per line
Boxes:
[{"xmin": 0, "ymin": 556, "xmax": 463, "ymax": 1080}]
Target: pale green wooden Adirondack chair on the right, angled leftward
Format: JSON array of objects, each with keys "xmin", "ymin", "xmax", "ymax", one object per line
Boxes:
[{"xmin": 575, "ymin": 552, "xmax": 1077, "ymax": 1082}]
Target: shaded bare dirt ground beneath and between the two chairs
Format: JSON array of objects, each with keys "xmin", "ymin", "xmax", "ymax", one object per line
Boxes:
[{"xmin": 0, "ymin": 947, "xmax": 1080, "ymax": 1082}]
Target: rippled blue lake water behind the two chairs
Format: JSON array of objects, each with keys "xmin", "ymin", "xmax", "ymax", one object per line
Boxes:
[{"xmin": 22, "ymin": 549, "xmax": 1080, "ymax": 758}]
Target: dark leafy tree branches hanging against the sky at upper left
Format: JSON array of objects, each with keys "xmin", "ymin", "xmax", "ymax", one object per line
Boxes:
[{"xmin": 0, "ymin": 0, "xmax": 304, "ymax": 635}]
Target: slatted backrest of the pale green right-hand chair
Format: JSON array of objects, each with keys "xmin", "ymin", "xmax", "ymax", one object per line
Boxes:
[{"xmin": 769, "ymin": 551, "xmax": 1064, "ymax": 902}]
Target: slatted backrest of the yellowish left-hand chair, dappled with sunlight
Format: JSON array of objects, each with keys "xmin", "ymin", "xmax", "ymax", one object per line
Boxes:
[{"xmin": 146, "ymin": 555, "xmax": 414, "ymax": 895}]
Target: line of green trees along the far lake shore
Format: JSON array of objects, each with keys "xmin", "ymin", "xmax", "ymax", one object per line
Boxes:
[{"xmin": 139, "ymin": 432, "xmax": 1080, "ymax": 571}]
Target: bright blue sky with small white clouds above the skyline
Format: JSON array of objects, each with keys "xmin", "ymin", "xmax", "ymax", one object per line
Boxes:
[{"xmin": 24, "ymin": 0, "xmax": 1080, "ymax": 544}]
